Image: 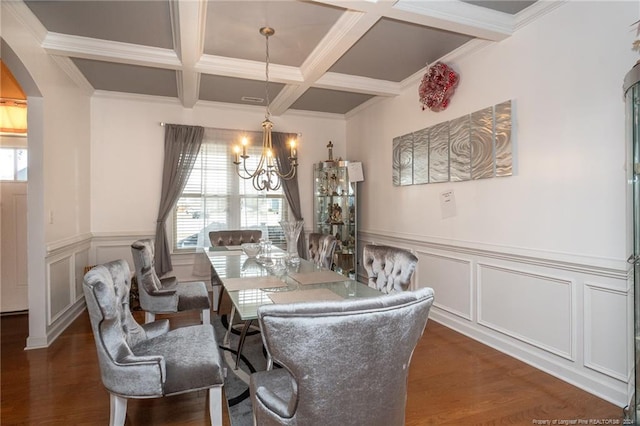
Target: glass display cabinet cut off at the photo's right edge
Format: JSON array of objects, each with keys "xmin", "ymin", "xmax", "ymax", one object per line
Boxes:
[{"xmin": 624, "ymin": 61, "xmax": 640, "ymax": 424}]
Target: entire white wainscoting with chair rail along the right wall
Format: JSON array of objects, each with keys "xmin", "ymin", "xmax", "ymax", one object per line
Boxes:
[{"xmin": 358, "ymin": 228, "xmax": 633, "ymax": 407}]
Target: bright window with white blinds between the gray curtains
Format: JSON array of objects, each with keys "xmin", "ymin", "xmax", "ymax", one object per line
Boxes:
[{"xmin": 173, "ymin": 129, "xmax": 288, "ymax": 250}]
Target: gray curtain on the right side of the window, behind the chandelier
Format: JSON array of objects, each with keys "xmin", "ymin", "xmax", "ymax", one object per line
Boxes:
[{"xmin": 271, "ymin": 132, "xmax": 307, "ymax": 259}]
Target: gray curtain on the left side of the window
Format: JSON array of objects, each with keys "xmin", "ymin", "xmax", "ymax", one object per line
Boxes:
[{"xmin": 155, "ymin": 124, "xmax": 204, "ymax": 277}]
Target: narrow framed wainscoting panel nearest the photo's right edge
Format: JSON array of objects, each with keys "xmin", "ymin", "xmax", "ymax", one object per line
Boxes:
[{"xmin": 584, "ymin": 283, "xmax": 633, "ymax": 381}]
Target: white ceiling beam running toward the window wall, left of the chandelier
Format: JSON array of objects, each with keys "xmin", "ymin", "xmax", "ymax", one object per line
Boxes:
[{"xmin": 170, "ymin": 0, "xmax": 207, "ymax": 108}]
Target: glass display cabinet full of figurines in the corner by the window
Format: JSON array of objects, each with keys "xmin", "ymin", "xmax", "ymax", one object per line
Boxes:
[{"xmin": 313, "ymin": 161, "xmax": 358, "ymax": 279}]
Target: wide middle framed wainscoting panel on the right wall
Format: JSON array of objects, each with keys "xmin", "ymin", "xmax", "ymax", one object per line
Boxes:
[{"xmin": 478, "ymin": 263, "xmax": 575, "ymax": 360}]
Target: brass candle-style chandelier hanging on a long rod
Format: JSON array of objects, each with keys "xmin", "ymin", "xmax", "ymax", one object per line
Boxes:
[{"xmin": 233, "ymin": 27, "xmax": 298, "ymax": 191}]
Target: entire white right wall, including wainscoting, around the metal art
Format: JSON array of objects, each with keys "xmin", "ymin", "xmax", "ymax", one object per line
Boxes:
[{"xmin": 347, "ymin": 1, "xmax": 639, "ymax": 406}]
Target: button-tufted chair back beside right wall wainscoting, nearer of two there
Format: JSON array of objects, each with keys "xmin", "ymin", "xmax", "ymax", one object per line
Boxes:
[{"xmin": 362, "ymin": 244, "xmax": 418, "ymax": 293}]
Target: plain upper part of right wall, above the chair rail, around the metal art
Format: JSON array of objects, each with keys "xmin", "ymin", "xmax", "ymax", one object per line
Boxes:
[{"xmin": 347, "ymin": 2, "xmax": 638, "ymax": 259}]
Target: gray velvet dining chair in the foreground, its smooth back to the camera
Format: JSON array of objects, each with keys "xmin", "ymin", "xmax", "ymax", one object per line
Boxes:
[{"xmin": 250, "ymin": 288, "xmax": 434, "ymax": 426}]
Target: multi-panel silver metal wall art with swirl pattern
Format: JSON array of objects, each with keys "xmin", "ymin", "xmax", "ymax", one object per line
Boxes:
[{"xmin": 392, "ymin": 100, "xmax": 513, "ymax": 186}]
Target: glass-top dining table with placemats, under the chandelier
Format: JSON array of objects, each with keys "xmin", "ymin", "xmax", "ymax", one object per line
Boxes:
[{"xmin": 206, "ymin": 246, "xmax": 382, "ymax": 321}]
